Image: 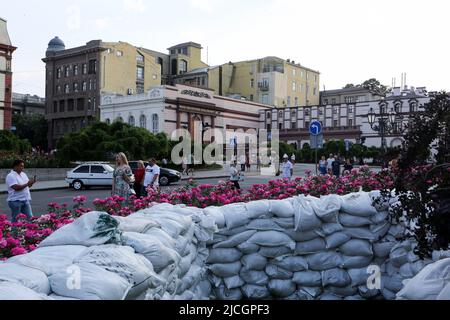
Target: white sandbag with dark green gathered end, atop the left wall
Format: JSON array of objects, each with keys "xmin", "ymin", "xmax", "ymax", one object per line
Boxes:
[{"xmin": 39, "ymin": 211, "xmax": 121, "ymax": 248}]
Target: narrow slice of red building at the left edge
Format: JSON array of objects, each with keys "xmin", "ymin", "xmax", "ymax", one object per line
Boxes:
[{"xmin": 0, "ymin": 18, "xmax": 17, "ymax": 130}]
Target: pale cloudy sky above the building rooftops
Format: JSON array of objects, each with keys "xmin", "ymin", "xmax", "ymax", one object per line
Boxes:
[{"xmin": 0, "ymin": 0, "xmax": 450, "ymax": 96}]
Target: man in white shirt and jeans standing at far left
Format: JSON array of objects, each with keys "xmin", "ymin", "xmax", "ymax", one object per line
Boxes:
[{"xmin": 6, "ymin": 160, "xmax": 36, "ymax": 222}]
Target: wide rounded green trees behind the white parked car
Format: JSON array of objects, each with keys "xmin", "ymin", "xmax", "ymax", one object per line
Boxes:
[{"xmin": 57, "ymin": 122, "xmax": 169, "ymax": 161}]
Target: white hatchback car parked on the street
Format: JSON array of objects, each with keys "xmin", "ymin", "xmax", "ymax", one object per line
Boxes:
[{"xmin": 66, "ymin": 162, "xmax": 114, "ymax": 191}]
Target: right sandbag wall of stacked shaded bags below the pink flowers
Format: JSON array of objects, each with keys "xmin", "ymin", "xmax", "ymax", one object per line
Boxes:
[{"xmin": 201, "ymin": 192, "xmax": 440, "ymax": 300}]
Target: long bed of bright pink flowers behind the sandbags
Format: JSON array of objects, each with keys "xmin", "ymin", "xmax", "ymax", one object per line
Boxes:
[{"xmin": 0, "ymin": 167, "xmax": 393, "ymax": 260}]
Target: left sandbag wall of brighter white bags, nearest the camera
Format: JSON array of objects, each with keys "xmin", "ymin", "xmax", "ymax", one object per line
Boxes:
[{"xmin": 0, "ymin": 204, "xmax": 216, "ymax": 300}]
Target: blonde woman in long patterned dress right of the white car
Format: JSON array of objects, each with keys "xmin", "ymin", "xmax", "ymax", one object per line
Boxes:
[{"xmin": 111, "ymin": 152, "xmax": 136, "ymax": 205}]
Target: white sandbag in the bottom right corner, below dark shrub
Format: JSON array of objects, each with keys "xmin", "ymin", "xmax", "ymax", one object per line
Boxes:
[{"xmin": 397, "ymin": 259, "xmax": 450, "ymax": 300}]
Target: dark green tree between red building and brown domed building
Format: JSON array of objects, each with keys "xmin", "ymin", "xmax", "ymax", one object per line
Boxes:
[{"xmin": 12, "ymin": 114, "xmax": 48, "ymax": 150}]
